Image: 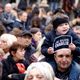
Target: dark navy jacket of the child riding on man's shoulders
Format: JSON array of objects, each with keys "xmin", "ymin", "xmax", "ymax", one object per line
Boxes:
[{"xmin": 41, "ymin": 29, "xmax": 80, "ymax": 62}]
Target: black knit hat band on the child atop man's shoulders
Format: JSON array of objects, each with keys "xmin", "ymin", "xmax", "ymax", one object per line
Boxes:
[{"xmin": 52, "ymin": 17, "xmax": 69, "ymax": 29}]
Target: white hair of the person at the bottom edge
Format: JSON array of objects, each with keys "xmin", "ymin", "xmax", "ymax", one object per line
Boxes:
[{"xmin": 24, "ymin": 62, "xmax": 54, "ymax": 80}]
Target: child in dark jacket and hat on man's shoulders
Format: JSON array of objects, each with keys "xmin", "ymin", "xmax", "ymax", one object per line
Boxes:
[{"xmin": 41, "ymin": 13, "xmax": 80, "ymax": 63}]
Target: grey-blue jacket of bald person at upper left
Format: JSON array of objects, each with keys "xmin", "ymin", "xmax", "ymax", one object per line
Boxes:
[{"xmin": 0, "ymin": 12, "xmax": 16, "ymax": 32}]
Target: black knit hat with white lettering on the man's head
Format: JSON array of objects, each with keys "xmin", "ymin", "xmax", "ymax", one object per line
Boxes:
[{"xmin": 53, "ymin": 35, "xmax": 72, "ymax": 51}]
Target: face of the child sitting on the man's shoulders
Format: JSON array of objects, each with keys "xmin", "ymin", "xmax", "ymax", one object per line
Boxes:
[{"xmin": 56, "ymin": 23, "xmax": 69, "ymax": 35}]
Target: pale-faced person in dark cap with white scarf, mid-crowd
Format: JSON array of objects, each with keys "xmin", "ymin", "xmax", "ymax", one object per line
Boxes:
[{"xmin": 31, "ymin": 28, "xmax": 45, "ymax": 61}]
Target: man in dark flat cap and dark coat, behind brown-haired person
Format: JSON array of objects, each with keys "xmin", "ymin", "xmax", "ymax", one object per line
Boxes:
[{"xmin": 20, "ymin": 31, "xmax": 36, "ymax": 65}]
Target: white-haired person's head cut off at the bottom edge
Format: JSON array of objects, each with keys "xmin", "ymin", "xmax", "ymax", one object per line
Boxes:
[{"xmin": 24, "ymin": 62, "xmax": 57, "ymax": 80}]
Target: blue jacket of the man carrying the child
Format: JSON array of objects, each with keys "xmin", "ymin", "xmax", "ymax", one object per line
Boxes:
[{"xmin": 51, "ymin": 61, "xmax": 80, "ymax": 80}]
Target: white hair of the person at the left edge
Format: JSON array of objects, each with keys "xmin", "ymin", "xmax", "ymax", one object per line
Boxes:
[{"xmin": 0, "ymin": 33, "xmax": 17, "ymax": 47}]
